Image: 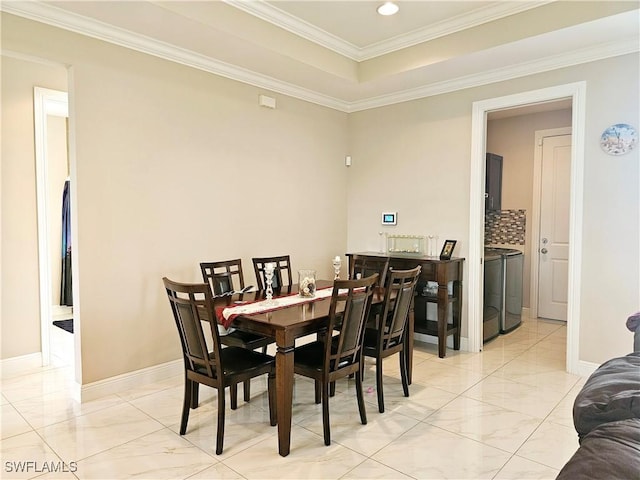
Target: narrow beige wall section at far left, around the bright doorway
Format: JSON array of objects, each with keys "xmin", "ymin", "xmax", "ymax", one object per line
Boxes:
[{"xmin": 0, "ymin": 54, "xmax": 67, "ymax": 358}]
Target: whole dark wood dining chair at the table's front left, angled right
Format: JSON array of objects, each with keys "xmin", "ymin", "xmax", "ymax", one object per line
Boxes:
[{"xmin": 162, "ymin": 277, "xmax": 276, "ymax": 455}]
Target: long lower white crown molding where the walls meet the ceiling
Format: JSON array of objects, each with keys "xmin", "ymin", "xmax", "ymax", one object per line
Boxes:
[{"xmin": 0, "ymin": 2, "xmax": 640, "ymax": 113}]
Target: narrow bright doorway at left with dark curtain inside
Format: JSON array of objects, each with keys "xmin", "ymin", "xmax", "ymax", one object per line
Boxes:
[{"xmin": 34, "ymin": 87, "xmax": 75, "ymax": 366}]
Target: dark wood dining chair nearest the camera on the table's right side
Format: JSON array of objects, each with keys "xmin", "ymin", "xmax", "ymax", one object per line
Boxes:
[{"xmin": 294, "ymin": 274, "xmax": 378, "ymax": 445}]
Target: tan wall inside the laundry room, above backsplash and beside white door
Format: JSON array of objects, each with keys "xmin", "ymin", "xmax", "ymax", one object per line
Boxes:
[{"xmin": 487, "ymin": 110, "xmax": 571, "ymax": 307}]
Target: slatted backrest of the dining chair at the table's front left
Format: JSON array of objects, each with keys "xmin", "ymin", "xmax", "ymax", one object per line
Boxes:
[{"xmin": 162, "ymin": 277, "xmax": 222, "ymax": 379}]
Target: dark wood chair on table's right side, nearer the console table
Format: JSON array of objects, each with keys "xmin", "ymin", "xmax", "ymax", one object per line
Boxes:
[{"xmin": 364, "ymin": 266, "xmax": 422, "ymax": 413}]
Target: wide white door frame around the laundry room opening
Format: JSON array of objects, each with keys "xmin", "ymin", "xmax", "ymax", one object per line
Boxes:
[{"xmin": 467, "ymin": 81, "xmax": 587, "ymax": 374}]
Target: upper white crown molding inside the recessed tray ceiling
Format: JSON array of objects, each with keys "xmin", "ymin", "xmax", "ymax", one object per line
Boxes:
[{"xmin": 223, "ymin": 0, "xmax": 551, "ymax": 62}]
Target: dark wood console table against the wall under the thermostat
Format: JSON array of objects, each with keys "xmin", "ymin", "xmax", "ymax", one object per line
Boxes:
[{"xmin": 347, "ymin": 252, "xmax": 464, "ymax": 364}]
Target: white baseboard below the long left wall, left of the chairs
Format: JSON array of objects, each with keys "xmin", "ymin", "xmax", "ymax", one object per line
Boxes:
[{"xmin": 79, "ymin": 359, "xmax": 184, "ymax": 402}]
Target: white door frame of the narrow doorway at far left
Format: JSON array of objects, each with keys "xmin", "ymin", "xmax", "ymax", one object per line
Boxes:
[{"xmin": 33, "ymin": 87, "xmax": 69, "ymax": 366}]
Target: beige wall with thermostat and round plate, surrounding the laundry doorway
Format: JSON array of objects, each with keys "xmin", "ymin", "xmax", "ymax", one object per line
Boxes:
[{"xmin": 348, "ymin": 55, "xmax": 640, "ymax": 363}]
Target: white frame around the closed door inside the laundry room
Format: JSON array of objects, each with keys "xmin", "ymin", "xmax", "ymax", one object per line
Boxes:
[{"xmin": 529, "ymin": 127, "xmax": 573, "ymax": 317}]
